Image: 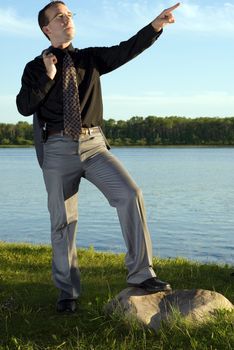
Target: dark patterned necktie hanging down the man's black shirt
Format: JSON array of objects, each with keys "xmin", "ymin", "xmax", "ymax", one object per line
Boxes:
[{"xmin": 63, "ymin": 53, "xmax": 82, "ymax": 140}]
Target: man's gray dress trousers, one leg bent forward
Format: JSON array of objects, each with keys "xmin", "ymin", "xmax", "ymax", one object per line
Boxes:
[{"xmin": 42, "ymin": 128, "xmax": 156, "ymax": 300}]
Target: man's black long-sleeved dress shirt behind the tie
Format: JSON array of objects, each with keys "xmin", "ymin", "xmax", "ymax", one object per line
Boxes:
[{"xmin": 16, "ymin": 24, "xmax": 162, "ymax": 130}]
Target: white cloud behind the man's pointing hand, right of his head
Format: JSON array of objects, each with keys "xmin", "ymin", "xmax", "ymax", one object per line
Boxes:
[{"xmin": 81, "ymin": 0, "xmax": 234, "ymax": 35}]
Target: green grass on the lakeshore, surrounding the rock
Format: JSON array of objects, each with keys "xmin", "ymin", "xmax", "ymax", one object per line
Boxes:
[{"xmin": 0, "ymin": 243, "xmax": 234, "ymax": 350}]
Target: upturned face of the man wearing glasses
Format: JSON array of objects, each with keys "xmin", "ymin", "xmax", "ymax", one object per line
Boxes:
[{"xmin": 43, "ymin": 4, "xmax": 75, "ymax": 45}]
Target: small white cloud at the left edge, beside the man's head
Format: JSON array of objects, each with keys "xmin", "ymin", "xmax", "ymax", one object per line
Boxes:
[{"xmin": 0, "ymin": 8, "xmax": 39, "ymax": 37}]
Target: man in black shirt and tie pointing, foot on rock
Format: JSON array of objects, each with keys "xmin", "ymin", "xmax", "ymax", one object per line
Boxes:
[{"xmin": 17, "ymin": 1, "xmax": 179, "ymax": 312}]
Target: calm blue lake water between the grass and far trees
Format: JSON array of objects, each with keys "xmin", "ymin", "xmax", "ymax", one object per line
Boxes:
[{"xmin": 0, "ymin": 147, "xmax": 234, "ymax": 265}]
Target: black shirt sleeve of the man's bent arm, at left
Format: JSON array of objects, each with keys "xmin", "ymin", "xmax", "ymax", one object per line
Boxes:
[{"xmin": 16, "ymin": 61, "xmax": 55, "ymax": 116}]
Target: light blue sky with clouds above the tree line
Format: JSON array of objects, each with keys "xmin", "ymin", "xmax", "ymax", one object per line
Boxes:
[{"xmin": 0, "ymin": 0, "xmax": 234, "ymax": 123}]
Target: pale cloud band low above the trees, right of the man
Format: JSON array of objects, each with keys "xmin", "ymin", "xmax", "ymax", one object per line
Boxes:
[{"xmin": 104, "ymin": 91, "xmax": 234, "ymax": 119}]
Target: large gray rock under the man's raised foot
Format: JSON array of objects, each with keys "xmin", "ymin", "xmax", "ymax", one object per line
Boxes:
[{"xmin": 105, "ymin": 287, "xmax": 234, "ymax": 331}]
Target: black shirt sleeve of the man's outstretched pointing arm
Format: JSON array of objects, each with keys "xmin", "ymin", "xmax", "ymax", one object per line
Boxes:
[{"xmin": 93, "ymin": 24, "xmax": 162, "ymax": 75}]
